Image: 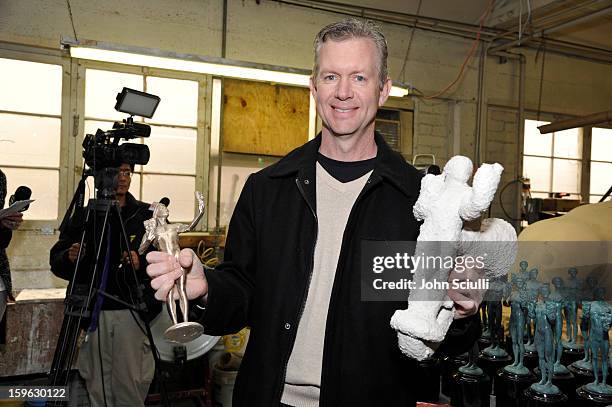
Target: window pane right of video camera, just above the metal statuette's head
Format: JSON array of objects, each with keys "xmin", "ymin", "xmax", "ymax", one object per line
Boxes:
[{"xmin": 142, "ymin": 174, "xmax": 196, "ymax": 222}]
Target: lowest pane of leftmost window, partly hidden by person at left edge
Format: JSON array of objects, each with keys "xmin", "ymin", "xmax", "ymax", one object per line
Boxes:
[{"xmin": 2, "ymin": 168, "xmax": 59, "ymax": 220}]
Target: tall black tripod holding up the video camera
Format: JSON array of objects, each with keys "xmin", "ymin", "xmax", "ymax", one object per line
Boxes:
[{"xmin": 47, "ymin": 168, "xmax": 169, "ymax": 406}]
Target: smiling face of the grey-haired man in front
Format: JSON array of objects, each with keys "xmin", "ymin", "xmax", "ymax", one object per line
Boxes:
[{"xmin": 310, "ymin": 38, "xmax": 391, "ymax": 142}]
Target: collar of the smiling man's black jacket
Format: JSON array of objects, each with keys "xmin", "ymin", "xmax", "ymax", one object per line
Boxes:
[{"xmin": 268, "ymin": 132, "xmax": 420, "ymax": 197}]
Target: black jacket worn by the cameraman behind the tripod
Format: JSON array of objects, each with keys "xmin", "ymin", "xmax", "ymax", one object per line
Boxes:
[{"xmin": 49, "ymin": 192, "xmax": 161, "ymax": 321}]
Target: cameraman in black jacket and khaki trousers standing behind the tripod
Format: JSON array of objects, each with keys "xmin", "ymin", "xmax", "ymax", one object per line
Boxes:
[{"xmin": 50, "ymin": 163, "xmax": 161, "ymax": 407}]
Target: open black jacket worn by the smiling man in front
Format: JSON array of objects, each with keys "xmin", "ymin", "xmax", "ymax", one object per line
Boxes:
[{"xmin": 194, "ymin": 135, "xmax": 480, "ymax": 407}]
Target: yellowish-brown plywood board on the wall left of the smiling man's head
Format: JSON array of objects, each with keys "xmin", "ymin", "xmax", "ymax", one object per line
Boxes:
[{"xmin": 223, "ymin": 79, "xmax": 309, "ymax": 156}]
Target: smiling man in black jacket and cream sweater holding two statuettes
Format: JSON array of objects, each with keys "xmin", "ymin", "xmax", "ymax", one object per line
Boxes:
[{"xmin": 147, "ymin": 19, "xmax": 480, "ymax": 407}]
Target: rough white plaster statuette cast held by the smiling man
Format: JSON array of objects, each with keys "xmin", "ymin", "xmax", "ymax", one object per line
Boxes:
[{"xmin": 391, "ymin": 156, "xmax": 516, "ymax": 360}]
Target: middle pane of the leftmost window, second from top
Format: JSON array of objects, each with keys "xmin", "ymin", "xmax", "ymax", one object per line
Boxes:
[{"xmin": 0, "ymin": 114, "xmax": 61, "ymax": 168}]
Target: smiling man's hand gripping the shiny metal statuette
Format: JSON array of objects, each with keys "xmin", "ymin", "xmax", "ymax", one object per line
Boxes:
[{"xmin": 147, "ymin": 249, "xmax": 208, "ymax": 301}]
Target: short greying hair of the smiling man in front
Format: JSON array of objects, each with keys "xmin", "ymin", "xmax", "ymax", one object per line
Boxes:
[{"xmin": 312, "ymin": 18, "xmax": 389, "ymax": 89}]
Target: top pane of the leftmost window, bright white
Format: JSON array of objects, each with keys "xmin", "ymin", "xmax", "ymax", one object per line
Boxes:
[{"xmin": 0, "ymin": 58, "xmax": 62, "ymax": 115}]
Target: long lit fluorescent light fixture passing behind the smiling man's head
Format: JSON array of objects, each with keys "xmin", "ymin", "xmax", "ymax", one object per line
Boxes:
[{"xmin": 61, "ymin": 39, "xmax": 408, "ymax": 97}]
